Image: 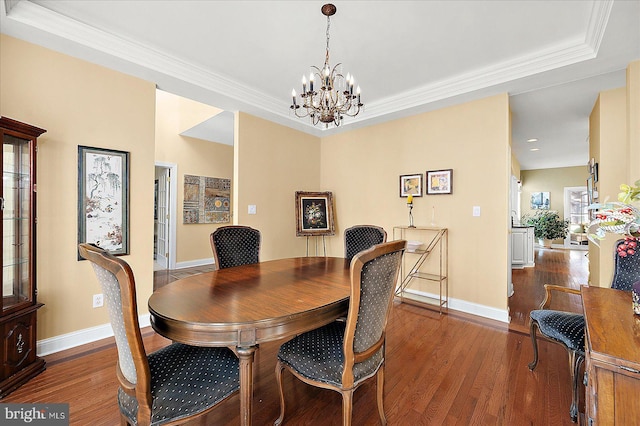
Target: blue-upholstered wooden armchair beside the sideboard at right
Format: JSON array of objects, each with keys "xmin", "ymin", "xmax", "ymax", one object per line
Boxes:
[{"xmin": 528, "ymin": 240, "xmax": 640, "ymax": 422}]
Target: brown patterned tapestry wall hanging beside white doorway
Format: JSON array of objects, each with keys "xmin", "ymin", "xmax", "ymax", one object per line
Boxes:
[{"xmin": 182, "ymin": 175, "xmax": 231, "ymax": 224}]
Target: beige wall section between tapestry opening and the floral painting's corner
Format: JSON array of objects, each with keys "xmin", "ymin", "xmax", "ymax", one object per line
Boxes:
[{"xmin": 233, "ymin": 113, "xmax": 321, "ymax": 260}]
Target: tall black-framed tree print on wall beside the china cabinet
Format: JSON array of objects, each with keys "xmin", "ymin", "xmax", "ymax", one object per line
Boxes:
[{"xmin": 78, "ymin": 146, "xmax": 129, "ymax": 260}]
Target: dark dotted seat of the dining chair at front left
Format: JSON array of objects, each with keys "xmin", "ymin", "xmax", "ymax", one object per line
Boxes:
[{"xmin": 118, "ymin": 343, "xmax": 240, "ymax": 425}]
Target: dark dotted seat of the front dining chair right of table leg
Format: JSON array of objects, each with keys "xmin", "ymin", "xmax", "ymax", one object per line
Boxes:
[{"xmin": 278, "ymin": 321, "xmax": 383, "ymax": 386}]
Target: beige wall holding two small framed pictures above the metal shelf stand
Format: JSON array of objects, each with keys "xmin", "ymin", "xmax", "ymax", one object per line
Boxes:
[{"xmin": 321, "ymin": 94, "xmax": 511, "ymax": 310}]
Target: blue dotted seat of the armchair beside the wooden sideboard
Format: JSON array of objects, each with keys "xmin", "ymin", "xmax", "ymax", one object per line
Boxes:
[{"xmin": 531, "ymin": 309, "xmax": 585, "ymax": 355}]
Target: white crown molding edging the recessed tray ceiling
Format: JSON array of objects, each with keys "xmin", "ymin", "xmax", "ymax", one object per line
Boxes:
[{"xmin": 7, "ymin": 0, "xmax": 613, "ymax": 134}]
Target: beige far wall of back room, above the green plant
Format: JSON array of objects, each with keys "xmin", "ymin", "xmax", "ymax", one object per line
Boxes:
[{"xmin": 520, "ymin": 165, "xmax": 589, "ymax": 238}]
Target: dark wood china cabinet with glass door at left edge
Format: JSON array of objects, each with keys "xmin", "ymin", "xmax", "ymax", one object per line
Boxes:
[{"xmin": 0, "ymin": 117, "xmax": 46, "ymax": 398}]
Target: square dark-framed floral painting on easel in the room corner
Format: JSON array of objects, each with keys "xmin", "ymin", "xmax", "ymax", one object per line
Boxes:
[{"xmin": 296, "ymin": 191, "xmax": 335, "ymax": 237}]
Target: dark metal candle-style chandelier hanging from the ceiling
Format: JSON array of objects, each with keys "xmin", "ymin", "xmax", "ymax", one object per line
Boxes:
[{"xmin": 290, "ymin": 4, "xmax": 364, "ymax": 127}]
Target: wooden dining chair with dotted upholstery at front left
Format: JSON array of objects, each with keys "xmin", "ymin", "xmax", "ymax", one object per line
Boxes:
[{"xmin": 79, "ymin": 244, "xmax": 240, "ymax": 425}]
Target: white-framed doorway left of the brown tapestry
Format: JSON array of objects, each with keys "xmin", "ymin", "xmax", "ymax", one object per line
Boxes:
[{"xmin": 153, "ymin": 162, "xmax": 177, "ymax": 271}]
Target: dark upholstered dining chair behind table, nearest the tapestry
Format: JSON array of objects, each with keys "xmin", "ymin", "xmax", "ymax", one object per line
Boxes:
[{"xmin": 210, "ymin": 225, "xmax": 261, "ymax": 269}]
